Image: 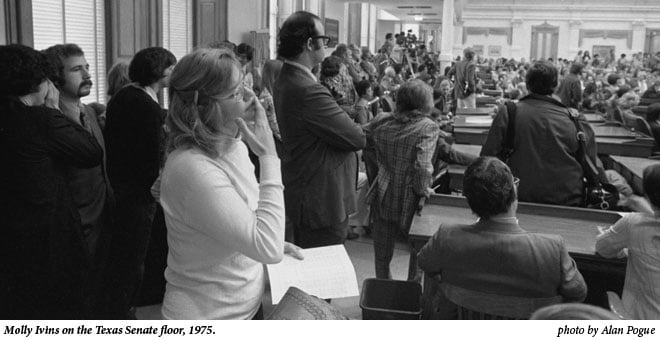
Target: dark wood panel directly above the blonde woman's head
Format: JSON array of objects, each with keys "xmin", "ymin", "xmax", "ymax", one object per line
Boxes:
[{"xmin": 193, "ymin": 0, "xmax": 227, "ymax": 46}]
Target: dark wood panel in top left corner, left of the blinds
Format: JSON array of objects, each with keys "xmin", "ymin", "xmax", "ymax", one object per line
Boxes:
[{"xmin": 2, "ymin": 0, "xmax": 34, "ymax": 46}]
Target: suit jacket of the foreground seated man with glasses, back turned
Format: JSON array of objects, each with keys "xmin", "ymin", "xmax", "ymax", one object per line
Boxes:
[{"xmin": 418, "ymin": 220, "xmax": 587, "ymax": 301}]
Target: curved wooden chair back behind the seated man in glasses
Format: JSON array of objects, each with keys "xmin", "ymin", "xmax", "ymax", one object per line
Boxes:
[{"xmin": 440, "ymin": 283, "xmax": 563, "ymax": 320}]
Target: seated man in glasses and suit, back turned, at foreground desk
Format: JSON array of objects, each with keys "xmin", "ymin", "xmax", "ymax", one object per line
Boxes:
[{"xmin": 418, "ymin": 157, "xmax": 587, "ymax": 318}]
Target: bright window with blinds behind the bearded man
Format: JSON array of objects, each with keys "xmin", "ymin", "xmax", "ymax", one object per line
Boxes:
[{"xmin": 32, "ymin": 0, "xmax": 106, "ymax": 103}]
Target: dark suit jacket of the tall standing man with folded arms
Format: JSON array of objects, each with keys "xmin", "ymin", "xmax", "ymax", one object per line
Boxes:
[{"xmin": 273, "ymin": 63, "xmax": 366, "ymax": 229}]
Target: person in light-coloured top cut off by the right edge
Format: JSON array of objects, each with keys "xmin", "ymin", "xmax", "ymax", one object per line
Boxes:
[{"xmin": 596, "ymin": 164, "xmax": 660, "ymax": 320}]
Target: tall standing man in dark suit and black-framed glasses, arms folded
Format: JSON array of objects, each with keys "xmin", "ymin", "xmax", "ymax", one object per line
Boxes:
[{"xmin": 273, "ymin": 11, "xmax": 366, "ymax": 248}]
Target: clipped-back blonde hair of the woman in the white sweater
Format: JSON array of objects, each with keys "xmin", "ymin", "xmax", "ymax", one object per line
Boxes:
[{"xmin": 166, "ymin": 48, "xmax": 240, "ymax": 157}]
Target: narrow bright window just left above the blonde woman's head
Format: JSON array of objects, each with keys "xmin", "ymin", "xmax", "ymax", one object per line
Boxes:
[{"xmin": 163, "ymin": 0, "xmax": 193, "ymax": 108}]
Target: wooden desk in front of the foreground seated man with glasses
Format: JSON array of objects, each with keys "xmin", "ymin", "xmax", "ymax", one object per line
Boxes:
[{"xmin": 409, "ymin": 195, "xmax": 626, "ymax": 316}]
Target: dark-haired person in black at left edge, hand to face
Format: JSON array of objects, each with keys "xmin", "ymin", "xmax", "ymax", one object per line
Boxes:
[{"xmin": 0, "ymin": 45, "xmax": 103, "ymax": 319}]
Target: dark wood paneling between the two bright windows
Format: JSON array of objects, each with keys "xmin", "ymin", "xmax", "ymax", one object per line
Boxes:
[{"xmin": 106, "ymin": 0, "xmax": 162, "ymax": 67}]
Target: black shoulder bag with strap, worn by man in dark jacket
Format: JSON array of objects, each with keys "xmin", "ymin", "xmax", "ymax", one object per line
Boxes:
[{"xmin": 568, "ymin": 108, "xmax": 619, "ymax": 210}]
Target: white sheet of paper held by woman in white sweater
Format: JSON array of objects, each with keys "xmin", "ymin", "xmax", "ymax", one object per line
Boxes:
[{"xmin": 267, "ymin": 245, "xmax": 359, "ymax": 304}]
